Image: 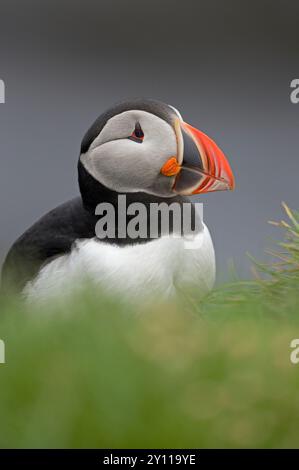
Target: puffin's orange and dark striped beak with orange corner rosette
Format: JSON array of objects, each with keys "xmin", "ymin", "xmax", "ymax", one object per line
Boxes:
[{"xmin": 161, "ymin": 119, "xmax": 235, "ymax": 195}]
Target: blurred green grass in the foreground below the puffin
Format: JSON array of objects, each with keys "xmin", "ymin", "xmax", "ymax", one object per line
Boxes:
[{"xmin": 0, "ymin": 208, "xmax": 299, "ymax": 448}]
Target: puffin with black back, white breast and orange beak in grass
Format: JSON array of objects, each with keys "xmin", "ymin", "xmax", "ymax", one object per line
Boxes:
[{"xmin": 2, "ymin": 98, "xmax": 235, "ymax": 300}]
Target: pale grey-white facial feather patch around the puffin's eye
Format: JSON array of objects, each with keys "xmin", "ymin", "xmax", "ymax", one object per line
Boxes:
[{"xmin": 81, "ymin": 110, "xmax": 177, "ymax": 197}]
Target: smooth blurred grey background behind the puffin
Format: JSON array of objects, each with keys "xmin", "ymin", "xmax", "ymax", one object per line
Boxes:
[{"xmin": 0, "ymin": 0, "xmax": 299, "ymax": 278}]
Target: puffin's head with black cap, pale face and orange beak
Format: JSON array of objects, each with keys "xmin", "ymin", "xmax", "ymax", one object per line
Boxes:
[{"xmin": 79, "ymin": 99, "xmax": 234, "ymax": 201}]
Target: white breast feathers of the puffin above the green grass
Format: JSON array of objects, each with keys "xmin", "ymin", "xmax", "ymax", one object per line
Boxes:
[{"xmin": 24, "ymin": 225, "xmax": 215, "ymax": 300}]
